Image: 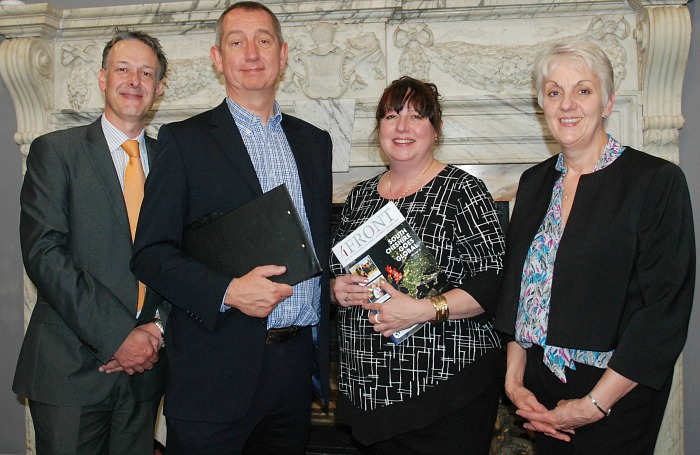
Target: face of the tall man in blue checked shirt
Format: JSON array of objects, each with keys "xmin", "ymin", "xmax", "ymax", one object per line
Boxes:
[{"xmin": 210, "ymin": 8, "xmax": 287, "ymax": 103}]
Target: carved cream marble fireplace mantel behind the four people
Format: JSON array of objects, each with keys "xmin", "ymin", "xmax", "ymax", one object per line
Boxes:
[{"xmin": 0, "ymin": 0, "xmax": 691, "ymax": 454}]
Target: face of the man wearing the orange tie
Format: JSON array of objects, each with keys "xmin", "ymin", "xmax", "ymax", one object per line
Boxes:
[{"xmin": 97, "ymin": 40, "xmax": 163, "ymax": 132}]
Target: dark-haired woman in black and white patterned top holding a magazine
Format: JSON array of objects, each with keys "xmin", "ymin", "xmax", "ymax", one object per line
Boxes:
[{"xmin": 331, "ymin": 77, "xmax": 504, "ymax": 454}]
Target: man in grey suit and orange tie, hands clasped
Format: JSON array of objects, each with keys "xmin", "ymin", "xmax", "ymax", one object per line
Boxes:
[{"xmin": 13, "ymin": 31, "xmax": 168, "ymax": 455}]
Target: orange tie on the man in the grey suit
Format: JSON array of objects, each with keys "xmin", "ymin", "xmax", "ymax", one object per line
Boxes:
[{"xmin": 122, "ymin": 139, "xmax": 146, "ymax": 314}]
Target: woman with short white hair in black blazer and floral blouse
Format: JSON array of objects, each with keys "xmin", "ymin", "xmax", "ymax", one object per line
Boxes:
[{"xmin": 496, "ymin": 41, "xmax": 695, "ymax": 455}]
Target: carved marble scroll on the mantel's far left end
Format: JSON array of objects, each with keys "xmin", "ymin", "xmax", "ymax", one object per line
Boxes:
[{"xmin": 0, "ymin": 38, "xmax": 53, "ymax": 162}]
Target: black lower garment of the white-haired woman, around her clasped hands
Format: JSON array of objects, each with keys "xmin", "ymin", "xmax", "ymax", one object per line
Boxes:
[{"xmin": 525, "ymin": 346, "xmax": 672, "ymax": 455}]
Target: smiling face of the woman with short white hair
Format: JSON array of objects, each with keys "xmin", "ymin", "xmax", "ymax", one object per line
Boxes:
[{"xmin": 542, "ymin": 58, "xmax": 615, "ymax": 152}]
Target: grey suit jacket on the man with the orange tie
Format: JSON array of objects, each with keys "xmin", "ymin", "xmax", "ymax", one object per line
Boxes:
[{"xmin": 13, "ymin": 119, "xmax": 168, "ymax": 406}]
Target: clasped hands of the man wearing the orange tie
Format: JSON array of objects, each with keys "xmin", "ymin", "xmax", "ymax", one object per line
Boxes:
[{"xmin": 100, "ymin": 323, "xmax": 163, "ymax": 375}]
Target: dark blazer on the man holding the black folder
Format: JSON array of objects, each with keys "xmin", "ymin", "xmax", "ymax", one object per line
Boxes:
[{"xmin": 132, "ymin": 101, "xmax": 332, "ymax": 422}]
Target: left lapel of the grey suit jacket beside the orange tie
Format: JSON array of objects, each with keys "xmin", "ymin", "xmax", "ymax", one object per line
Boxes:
[{"xmin": 83, "ymin": 118, "xmax": 131, "ymax": 243}]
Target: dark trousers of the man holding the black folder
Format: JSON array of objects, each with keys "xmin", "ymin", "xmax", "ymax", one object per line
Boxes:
[{"xmin": 166, "ymin": 328, "xmax": 313, "ymax": 455}]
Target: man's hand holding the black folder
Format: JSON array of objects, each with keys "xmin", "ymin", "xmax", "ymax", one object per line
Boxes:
[{"xmin": 224, "ymin": 265, "xmax": 293, "ymax": 318}]
